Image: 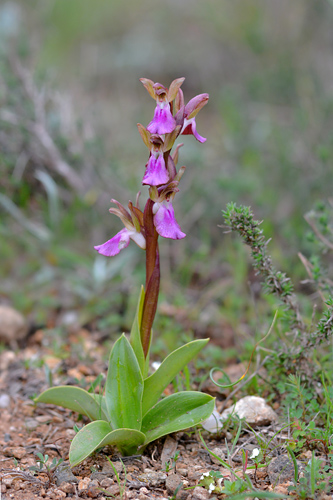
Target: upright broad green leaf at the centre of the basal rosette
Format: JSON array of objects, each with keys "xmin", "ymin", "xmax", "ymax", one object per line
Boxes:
[{"xmin": 105, "ymin": 334, "xmax": 143, "ymax": 430}]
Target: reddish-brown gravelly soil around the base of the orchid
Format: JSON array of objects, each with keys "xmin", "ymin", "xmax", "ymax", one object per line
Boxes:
[{"xmin": 0, "ymin": 331, "xmax": 316, "ymax": 500}]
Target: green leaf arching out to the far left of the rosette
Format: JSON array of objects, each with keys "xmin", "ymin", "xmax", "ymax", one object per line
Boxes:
[{"xmin": 35, "ymin": 385, "xmax": 109, "ymax": 421}]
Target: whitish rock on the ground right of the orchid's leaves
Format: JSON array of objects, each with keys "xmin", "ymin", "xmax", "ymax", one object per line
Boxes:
[{"xmin": 221, "ymin": 396, "xmax": 278, "ymax": 426}]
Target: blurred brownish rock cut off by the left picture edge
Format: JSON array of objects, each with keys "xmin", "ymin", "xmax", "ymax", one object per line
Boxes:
[{"xmin": 0, "ymin": 305, "xmax": 29, "ymax": 346}]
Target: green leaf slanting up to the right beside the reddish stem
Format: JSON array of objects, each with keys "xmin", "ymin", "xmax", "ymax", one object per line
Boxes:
[{"xmin": 142, "ymin": 339, "xmax": 209, "ymax": 415}]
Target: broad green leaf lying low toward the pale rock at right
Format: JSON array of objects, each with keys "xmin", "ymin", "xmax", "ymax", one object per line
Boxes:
[{"xmin": 141, "ymin": 391, "xmax": 215, "ymax": 444}]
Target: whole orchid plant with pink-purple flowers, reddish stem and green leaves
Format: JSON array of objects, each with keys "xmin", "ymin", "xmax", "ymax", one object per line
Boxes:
[{"xmin": 35, "ymin": 78, "xmax": 214, "ymax": 466}]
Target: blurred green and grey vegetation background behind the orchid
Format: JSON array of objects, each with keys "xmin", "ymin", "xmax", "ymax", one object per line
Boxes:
[{"xmin": 0, "ymin": 0, "xmax": 333, "ymax": 357}]
